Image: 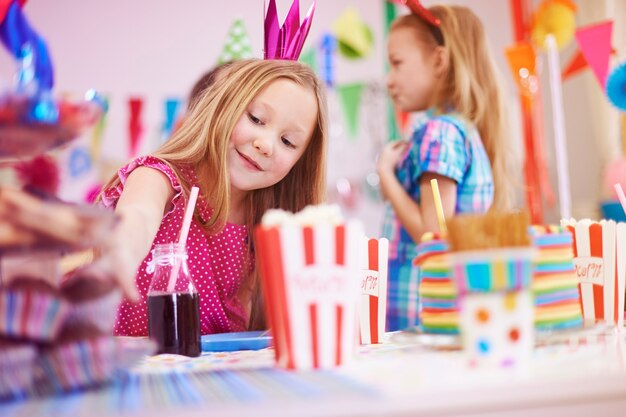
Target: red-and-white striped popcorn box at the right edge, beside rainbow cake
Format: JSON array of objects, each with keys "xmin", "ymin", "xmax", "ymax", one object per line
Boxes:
[{"xmin": 561, "ymin": 219, "xmax": 626, "ymax": 329}]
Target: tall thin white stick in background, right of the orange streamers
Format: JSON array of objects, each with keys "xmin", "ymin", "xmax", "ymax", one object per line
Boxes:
[{"xmin": 545, "ymin": 34, "xmax": 571, "ymax": 219}]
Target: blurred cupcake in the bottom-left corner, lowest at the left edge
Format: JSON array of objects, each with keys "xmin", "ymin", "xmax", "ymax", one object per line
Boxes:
[{"xmin": 0, "ymin": 339, "xmax": 37, "ymax": 401}]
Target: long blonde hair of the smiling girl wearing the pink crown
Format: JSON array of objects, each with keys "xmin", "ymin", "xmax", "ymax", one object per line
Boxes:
[{"xmin": 102, "ymin": 59, "xmax": 328, "ymax": 328}]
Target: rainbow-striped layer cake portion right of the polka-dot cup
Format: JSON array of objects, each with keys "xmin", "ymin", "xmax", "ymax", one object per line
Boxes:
[{"xmin": 530, "ymin": 226, "xmax": 583, "ymax": 330}]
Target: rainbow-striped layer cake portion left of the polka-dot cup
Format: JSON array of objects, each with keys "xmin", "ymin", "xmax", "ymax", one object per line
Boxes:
[{"xmin": 414, "ymin": 233, "xmax": 459, "ymax": 334}]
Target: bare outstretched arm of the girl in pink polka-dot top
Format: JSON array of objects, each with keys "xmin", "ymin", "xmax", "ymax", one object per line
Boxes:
[{"xmin": 90, "ymin": 167, "xmax": 175, "ymax": 300}]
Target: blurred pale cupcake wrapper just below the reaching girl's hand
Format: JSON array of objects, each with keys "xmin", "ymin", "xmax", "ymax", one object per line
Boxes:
[{"xmin": 66, "ymin": 290, "xmax": 122, "ymax": 334}]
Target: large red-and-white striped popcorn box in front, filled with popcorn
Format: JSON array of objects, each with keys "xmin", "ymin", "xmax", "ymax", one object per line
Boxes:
[{"xmin": 255, "ymin": 216, "xmax": 364, "ymax": 369}]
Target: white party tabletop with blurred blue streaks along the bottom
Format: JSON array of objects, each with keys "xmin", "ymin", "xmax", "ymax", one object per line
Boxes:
[{"xmin": 0, "ymin": 330, "xmax": 626, "ymax": 417}]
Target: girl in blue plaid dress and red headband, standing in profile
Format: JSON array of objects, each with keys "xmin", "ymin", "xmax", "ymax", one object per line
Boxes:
[{"xmin": 377, "ymin": 2, "xmax": 513, "ymax": 331}]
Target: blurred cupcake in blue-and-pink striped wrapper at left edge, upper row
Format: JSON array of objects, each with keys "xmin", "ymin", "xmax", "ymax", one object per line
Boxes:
[{"xmin": 0, "ymin": 276, "xmax": 69, "ymax": 342}]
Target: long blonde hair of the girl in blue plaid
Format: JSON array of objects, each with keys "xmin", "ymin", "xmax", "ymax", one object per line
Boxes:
[{"xmin": 391, "ymin": 5, "xmax": 515, "ymax": 210}]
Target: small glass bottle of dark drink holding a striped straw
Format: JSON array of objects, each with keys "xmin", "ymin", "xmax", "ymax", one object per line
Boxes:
[{"xmin": 148, "ymin": 243, "xmax": 202, "ymax": 357}]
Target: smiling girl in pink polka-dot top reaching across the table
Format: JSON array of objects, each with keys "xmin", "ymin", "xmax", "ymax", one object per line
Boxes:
[{"xmin": 92, "ymin": 60, "xmax": 327, "ymax": 336}]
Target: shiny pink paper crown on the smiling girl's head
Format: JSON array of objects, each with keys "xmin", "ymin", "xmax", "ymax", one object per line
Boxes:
[{"xmin": 263, "ymin": 0, "xmax": 315, "ymax": 61}]
